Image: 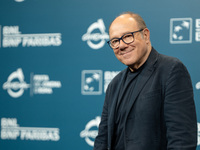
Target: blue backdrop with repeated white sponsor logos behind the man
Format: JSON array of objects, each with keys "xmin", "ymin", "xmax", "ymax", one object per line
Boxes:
[{"xmin": 0, "ymin": 0, "xmax": 200, "ymax": 150}]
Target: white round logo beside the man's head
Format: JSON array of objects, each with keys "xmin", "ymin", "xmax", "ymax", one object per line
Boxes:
[{"xmin": 82, "ymin": 19, "xmax": 109, "ymax": 49}]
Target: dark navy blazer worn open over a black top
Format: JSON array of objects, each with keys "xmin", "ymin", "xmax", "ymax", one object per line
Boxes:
[{"xmin": 94, "ymin": 48, "xmax": 197, "ymax": 150}]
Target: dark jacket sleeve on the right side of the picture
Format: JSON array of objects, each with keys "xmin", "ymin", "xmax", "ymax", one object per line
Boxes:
[{"xmin": 164, "ymin": 61, "xmax": 197, "ymax": 150}]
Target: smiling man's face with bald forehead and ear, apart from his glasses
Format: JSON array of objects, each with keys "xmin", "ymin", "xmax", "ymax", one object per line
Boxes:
[{"xmin": 109, "ymin": 14, "xmax": 151, "ymax": 70}]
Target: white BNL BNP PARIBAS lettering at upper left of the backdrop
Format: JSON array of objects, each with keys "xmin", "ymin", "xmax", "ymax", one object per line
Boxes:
[{"xmin": 2, "ymin": 26, "xmax": 62, "ymax": 48}]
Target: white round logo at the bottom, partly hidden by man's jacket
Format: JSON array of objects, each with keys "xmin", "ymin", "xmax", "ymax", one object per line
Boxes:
[{"xmin": 80, "ymin": 116, "xmax": 101, "ymax": 146}]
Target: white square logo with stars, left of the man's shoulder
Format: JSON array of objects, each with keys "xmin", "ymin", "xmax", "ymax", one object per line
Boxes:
[{"xmin": 81, "ymin": 70, "xmax": 102, "ymax": 95}]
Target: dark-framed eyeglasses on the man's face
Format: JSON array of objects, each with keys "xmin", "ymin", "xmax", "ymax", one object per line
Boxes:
[{"xmin": 107, "ymin": 29, "xmax": 144, "ymax": 49}]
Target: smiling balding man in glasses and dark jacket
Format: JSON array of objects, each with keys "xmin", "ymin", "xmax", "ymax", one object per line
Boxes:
[{"xmin": 94, "ymin": 12, "xmax": 197, "ymax": 150}]
